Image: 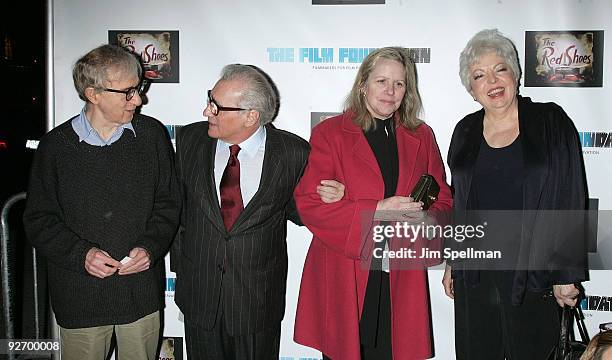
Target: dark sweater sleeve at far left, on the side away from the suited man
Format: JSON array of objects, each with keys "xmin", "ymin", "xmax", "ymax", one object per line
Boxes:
[{"xmin": 23, "ymin": 133, "xmax": 99, "ymax": 273}]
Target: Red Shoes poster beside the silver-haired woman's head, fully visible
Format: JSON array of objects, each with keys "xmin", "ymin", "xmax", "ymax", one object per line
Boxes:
[{"xmin": 525, "ymin": 30, "xmax": 604, "ymax": 87}]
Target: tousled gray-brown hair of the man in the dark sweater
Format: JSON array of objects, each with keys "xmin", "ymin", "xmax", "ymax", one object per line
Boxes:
[{"xmin": 72, "ymin": 44, "xmax": 142, "ymax": 101}]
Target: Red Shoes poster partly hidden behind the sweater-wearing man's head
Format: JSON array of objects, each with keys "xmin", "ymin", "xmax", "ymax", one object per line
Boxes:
[{"xmin": 108, "ymin": 30, "xmax": 179, "ymax": 83}]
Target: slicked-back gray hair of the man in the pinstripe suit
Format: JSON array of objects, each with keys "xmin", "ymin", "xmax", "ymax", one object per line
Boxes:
[{"xmin": 219, "ymin": 64, "xmax": 280, "ymax": 126}]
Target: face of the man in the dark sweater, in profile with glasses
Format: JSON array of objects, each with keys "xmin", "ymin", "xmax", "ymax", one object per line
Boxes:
[{"xmin": 90, "ymin": 76, "xmax": 142, "ymax": 126}]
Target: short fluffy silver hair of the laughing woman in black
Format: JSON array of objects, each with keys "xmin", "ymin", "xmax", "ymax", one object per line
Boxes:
[{"xmin": 459, "ymin": 29, "xmax": 521, "ymax": 92}]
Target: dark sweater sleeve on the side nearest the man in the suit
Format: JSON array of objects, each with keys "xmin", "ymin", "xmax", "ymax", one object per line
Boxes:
[{"xmin": 134, "ymin": 126, "xmax": 181, "ymax": 263}]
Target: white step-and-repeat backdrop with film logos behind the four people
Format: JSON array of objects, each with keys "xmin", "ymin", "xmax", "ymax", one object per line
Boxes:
[{"xmin": 51, "ymin": 0, "xmax": 612, "ymax": 360}]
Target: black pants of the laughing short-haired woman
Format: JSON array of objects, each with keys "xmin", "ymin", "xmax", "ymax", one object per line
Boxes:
[{"xmin": 453, "ymin": 271, "xmax": 560, "ymax": 360}]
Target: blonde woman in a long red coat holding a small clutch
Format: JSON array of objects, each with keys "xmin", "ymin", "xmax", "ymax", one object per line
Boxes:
[{"xmin": 294, "ymin": 47, "xmax": 452, "ymax": 360}]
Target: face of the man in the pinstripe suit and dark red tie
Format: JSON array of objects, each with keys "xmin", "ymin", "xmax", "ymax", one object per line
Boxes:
[{"xmin": 204, "ymin": 80, "xmax": 258, "ymax": 144}]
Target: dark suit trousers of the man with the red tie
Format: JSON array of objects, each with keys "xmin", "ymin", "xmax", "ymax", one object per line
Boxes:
[{"xmin": 185, "ymin": 316, "xmax": 280, "ymax": 360}]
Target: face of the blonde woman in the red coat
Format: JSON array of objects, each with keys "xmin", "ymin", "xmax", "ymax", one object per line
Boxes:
[{"xmin": 363, "ymin": 58, "xmax": 406, "ymax": 119}]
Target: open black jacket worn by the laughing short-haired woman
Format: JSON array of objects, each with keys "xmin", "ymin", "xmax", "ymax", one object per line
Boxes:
[{"xmin": 448, "ymin": 96, "xmax": 587, "ymax": 304}]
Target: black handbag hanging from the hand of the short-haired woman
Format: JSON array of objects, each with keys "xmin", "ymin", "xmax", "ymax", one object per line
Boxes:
[{"xmin": 548, "ymin": 305, "xmax": 590, "ymax": 360}]
